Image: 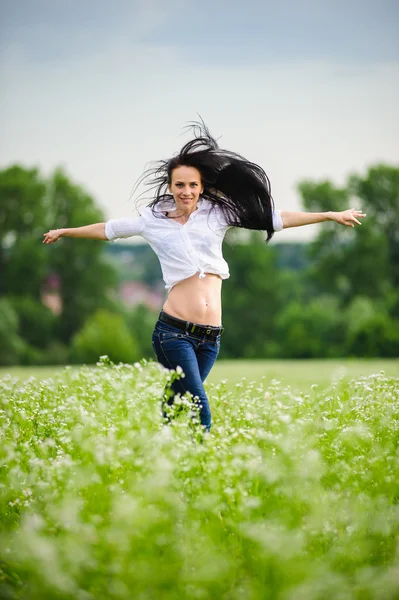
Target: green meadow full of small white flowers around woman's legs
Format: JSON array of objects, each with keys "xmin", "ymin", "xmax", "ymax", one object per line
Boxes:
[{"xmin": 0, "ymin": 359, "xmax": 399, "ymax": 600}]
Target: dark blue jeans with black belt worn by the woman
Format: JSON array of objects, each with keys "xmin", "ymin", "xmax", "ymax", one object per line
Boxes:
[{"xmin": 152, "ymin": 320, "xmax": 220, "ymax": 431}]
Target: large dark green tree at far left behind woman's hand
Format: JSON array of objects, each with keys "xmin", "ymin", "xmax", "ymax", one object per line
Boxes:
[{"xmin": 0, "ymin": 165, "xmax": 121, "ymax": 346}]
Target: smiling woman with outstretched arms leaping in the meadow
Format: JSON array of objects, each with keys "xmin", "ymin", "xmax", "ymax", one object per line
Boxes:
[{"xmin": 44, "ymin": 124, "xmax": 366, "ymax": 431}]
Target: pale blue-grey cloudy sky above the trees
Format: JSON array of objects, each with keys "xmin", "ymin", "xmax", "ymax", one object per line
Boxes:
[{"xmin": 0, "ymin": 0, "xmax": 399, "ymax": 241}]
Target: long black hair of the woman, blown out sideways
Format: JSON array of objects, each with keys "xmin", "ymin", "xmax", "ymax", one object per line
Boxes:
[{"xmin": 135, "ymin": 120, "xmax": 274, "ymax": 241}]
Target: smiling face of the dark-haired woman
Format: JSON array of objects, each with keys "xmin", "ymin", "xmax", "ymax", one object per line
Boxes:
[{"xmin": 169, "ymin": 167, "xmax": 204, "ymax": 213}]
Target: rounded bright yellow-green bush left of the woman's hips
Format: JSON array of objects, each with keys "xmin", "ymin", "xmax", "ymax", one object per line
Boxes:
[{"xmin": 71, "ymin": 309, "xmax": 140, "ymax": 363}]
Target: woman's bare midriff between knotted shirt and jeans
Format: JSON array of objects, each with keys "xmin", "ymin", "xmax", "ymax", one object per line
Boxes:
[{"xmin": 163, "ymin": 273, "xmax": 222, "ymax": 327}]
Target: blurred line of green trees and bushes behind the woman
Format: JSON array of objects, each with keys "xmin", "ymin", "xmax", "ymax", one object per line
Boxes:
[{"xmin": 0, "ymin": 165, "xmax": 399, "ymax": 365}]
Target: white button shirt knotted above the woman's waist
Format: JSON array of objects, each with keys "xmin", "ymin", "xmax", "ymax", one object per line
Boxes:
[{"xmin": 105, "ymin": 198, "xmax": 283, "ymax": 292}]
